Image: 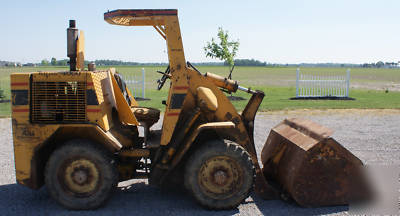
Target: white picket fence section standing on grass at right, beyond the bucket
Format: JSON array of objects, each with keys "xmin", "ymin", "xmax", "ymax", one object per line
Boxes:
[{"xmin": 296, "ymin": 68, "xmax": 350, "ymax": 98}]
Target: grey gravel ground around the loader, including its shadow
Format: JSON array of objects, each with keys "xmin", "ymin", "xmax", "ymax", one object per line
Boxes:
[{"xmin": 0, "ymin": 110, "xmax": 400, "ymax": 216}]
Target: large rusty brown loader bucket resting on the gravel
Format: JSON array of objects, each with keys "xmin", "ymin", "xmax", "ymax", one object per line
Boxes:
[{"xmin": 261, "ymin": 119, "xmax": 363, "ymax": 207}]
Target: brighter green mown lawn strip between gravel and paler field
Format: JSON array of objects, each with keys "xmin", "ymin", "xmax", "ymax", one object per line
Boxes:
[{"xmin": 134, "ymin": 87, "xmax": 400, "ymax": 111}]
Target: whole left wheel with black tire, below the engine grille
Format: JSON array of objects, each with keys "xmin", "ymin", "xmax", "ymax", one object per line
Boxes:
[{"xmin": 45, "ymin": 140, "xmax": 118, "ymax": 210}]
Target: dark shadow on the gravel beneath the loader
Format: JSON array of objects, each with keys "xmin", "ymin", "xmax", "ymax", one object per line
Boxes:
[{"xmin": 0, "ymin": 182, "xmax": 348, "ymax": 216}]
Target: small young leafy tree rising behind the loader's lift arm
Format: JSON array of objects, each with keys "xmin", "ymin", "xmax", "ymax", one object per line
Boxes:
[{"xmin": 204, "ymin": 27, "xmax": 239, "ymax": 79}]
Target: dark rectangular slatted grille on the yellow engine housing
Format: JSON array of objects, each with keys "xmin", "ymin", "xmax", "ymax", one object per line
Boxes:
[{"xmin": 31, "ymin": 82, "xmax": 86, "ymax": 123}]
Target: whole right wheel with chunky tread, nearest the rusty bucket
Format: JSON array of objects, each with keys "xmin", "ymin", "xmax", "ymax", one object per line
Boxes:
[{"xmin": 184, "ymin": 140, "xmax": 254, "ymax": 210}]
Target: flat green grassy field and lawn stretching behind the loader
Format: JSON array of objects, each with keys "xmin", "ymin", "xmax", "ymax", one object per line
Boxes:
[{"xmin": 0, "ymin": 66, "xmax": 400, "ymax": 116}]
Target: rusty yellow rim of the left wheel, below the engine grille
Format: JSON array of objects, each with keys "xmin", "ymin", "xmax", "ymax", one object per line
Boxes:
[{"xmin": 58, "ymin": 158, "xmax": 101, "ymax": 197}]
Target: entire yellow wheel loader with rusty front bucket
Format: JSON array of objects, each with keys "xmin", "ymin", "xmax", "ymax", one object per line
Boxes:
[{"xmin": 11, "ymin": 9, "xmax": 368, "ymax": 210}]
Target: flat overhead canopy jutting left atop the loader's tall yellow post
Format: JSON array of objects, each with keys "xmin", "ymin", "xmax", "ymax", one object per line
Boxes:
[{"xmin": 104, "ymin": 9, "xmax": 178, "ymax": 26}]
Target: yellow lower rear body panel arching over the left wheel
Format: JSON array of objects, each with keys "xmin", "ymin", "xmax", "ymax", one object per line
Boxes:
[{"xmin": 13, "ymin": 123, "xmax": 122, "ymax": 189}]
